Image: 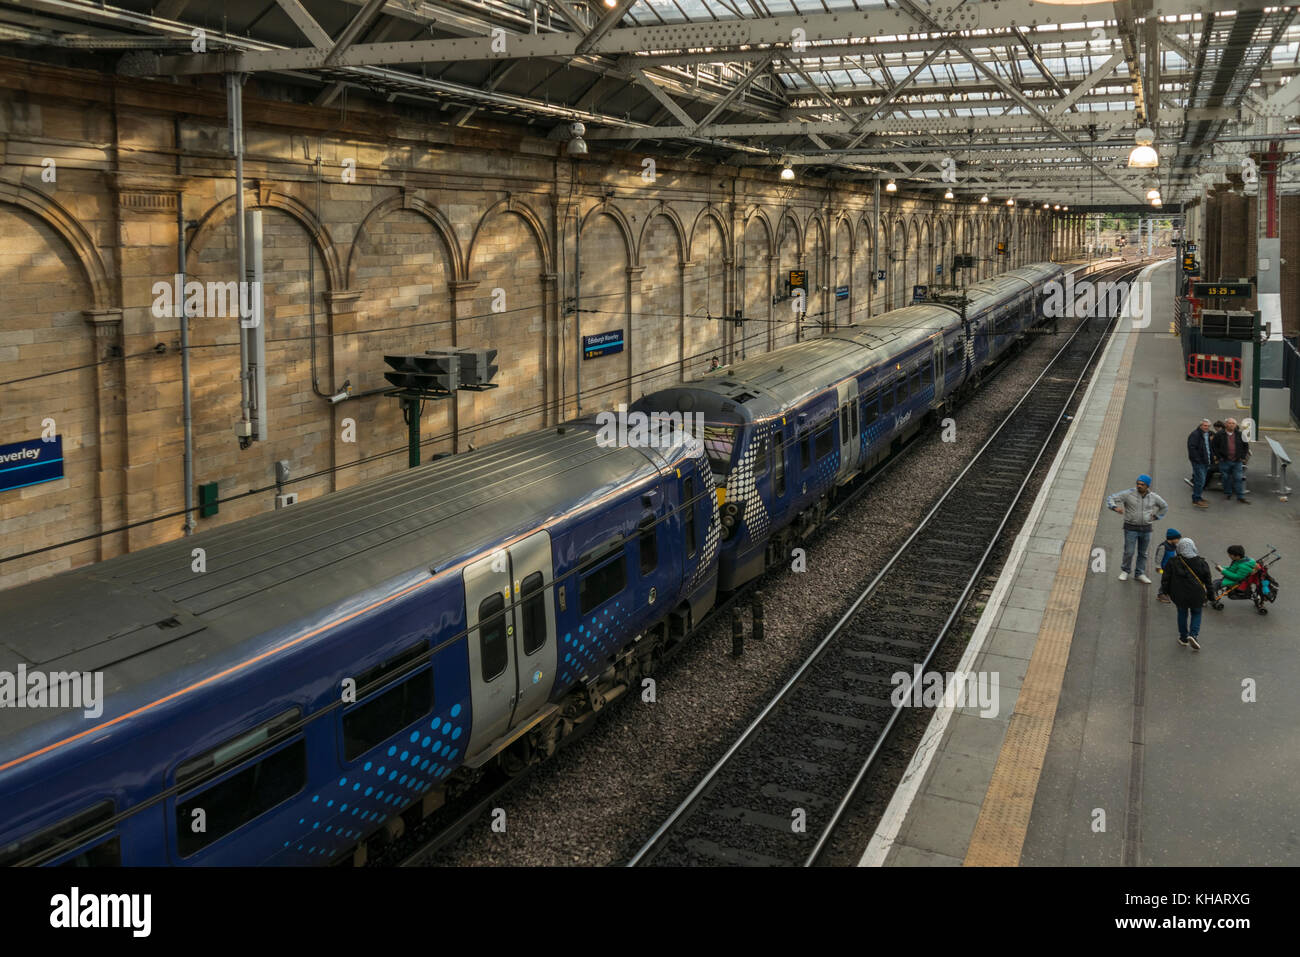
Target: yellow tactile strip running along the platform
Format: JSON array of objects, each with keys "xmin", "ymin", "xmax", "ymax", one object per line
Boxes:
[{"xmin": 965, "ymin": 323, "xmax": 1138, "ymax": 867}]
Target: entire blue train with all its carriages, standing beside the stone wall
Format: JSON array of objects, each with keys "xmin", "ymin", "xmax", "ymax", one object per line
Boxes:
[{"xmin": 0, "ymin": 257, "xmax": 1061, "ymax": 866}]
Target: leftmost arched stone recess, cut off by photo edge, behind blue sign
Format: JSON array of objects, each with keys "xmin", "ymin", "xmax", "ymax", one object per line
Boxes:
[{"xmin": 0, "ymin": 195, "xmax": 100, "ymax": 589}]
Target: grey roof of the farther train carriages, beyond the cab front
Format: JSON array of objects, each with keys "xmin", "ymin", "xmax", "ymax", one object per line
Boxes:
[{"xmin": 637, "ymin": 263, "xmax": 1061, "ymax": 421}]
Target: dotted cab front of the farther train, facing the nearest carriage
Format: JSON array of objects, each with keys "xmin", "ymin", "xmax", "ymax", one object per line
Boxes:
[{"xmin": 632, "ymin": 384, "xmax": 767, "ymax": 592}]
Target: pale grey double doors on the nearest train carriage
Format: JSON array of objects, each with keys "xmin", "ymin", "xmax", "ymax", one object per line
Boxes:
[{"xmin": 464, "ymin": 532, "xmax": 555, "ymax": 755}]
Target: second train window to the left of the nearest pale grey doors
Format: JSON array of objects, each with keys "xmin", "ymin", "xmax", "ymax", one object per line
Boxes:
[{"xmin": 176, "ymin": 707, "xmax": 307, "ymax": 857}]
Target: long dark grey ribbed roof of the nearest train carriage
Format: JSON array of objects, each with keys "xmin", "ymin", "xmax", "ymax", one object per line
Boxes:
[{"xmin": 0, "ymin": 424, "xmax": 702, "ymax": 735}]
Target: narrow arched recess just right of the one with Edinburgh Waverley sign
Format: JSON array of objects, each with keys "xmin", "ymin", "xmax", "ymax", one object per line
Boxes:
[{"xmin": 639, "ymin": 205, "xmax": 691, "ymax": 397}]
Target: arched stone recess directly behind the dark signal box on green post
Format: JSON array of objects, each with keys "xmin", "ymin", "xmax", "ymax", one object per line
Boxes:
[{"xmin": 345, "ymin": 194, "xmax": 462, "ymax": 486}]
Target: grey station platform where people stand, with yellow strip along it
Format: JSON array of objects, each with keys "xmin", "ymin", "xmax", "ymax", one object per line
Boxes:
[{"xmin": 862, "ymin": 261, "xmax": 1300, "ymax": 866}]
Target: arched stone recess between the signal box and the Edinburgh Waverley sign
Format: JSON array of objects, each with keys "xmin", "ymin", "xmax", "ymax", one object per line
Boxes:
[{"xmin": 467, "ymin": 200, "xmax": 548, "ymax": 450}]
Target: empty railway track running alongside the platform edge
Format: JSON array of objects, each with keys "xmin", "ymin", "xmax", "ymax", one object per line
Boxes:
[{"xmin": 629, "ymin": 263, "xmax": 1138, "ymax": 866}]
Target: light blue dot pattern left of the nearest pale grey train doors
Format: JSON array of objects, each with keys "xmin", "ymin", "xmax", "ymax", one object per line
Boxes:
[{"xmin": 276, "ymin": 702, "xmax": 468, "ymax": 863}]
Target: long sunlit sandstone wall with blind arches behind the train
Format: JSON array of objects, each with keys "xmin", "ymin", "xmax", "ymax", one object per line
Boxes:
[{"xmin": 0, "ymin": 60, "xmax": 1048, "ymax": 588}]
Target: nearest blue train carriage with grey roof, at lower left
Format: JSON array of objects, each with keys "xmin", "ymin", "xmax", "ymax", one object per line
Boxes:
[{"xmin": 0, "ymin": 424, "xmax": 716, "ymax": 865}]
